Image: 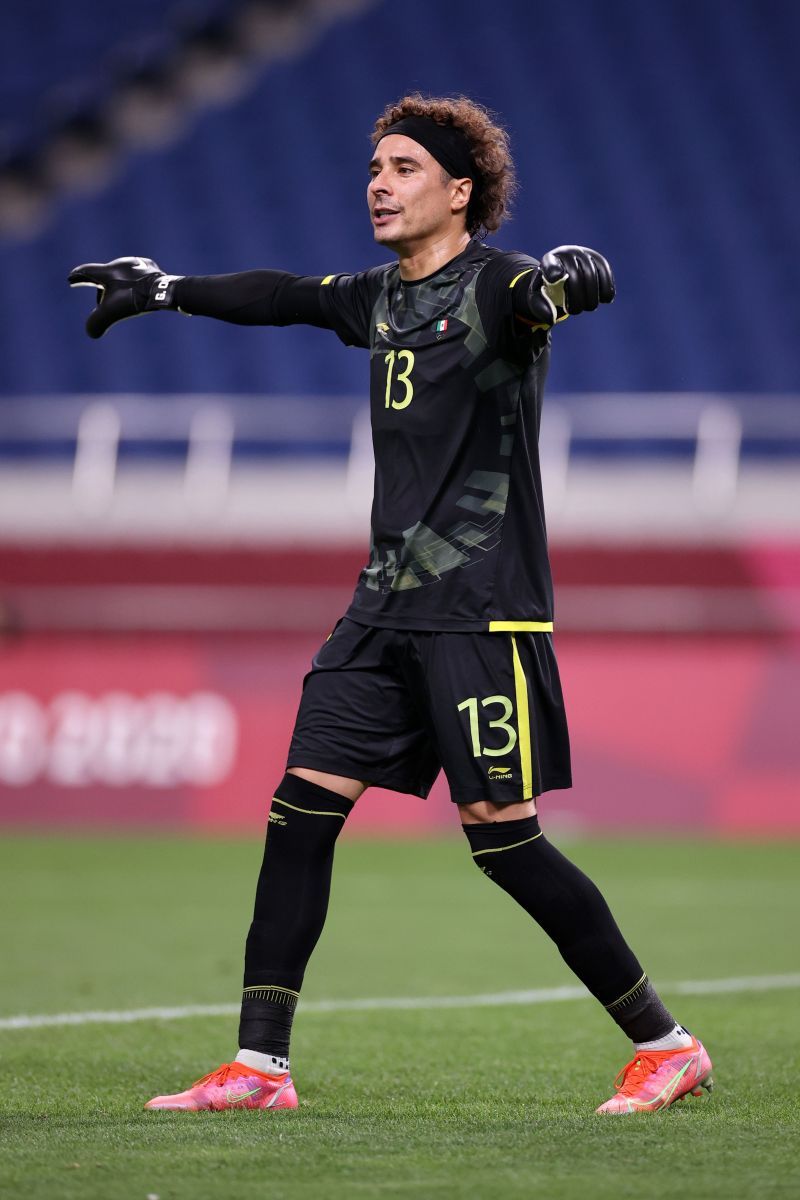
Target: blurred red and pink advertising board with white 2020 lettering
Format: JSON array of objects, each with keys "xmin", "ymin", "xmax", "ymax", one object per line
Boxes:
[{"xmin": 0, "ymin": 635, "xmax": 800, "ymax": 835}]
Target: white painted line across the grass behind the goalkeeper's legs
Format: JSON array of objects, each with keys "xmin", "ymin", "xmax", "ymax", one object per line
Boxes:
[{"xmin": 0, "ymin": 974, "xmax": 800, "ymax": 1031}]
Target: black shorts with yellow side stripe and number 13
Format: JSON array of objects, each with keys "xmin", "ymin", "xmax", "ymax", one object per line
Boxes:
[{"xmin": 288, "ymin": 617, "xmax": 572, "ymax": 804}]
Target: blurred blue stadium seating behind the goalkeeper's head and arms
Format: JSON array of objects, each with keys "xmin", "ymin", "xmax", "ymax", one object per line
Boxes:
[{"xmin": 0, "ymin": 0, "xmax": 800, "ymax": 395}]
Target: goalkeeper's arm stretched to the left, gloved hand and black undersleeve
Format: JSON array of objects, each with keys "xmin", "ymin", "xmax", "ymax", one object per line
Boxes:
[{"xmin": 68, "ymin": 258, "xmax": 332, "ymax": 337}]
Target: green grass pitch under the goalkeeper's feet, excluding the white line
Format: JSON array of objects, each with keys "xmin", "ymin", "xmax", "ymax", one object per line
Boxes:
[{"xmin": 0, "ymin": 829, "xmax": 800, "ymax": 1200}]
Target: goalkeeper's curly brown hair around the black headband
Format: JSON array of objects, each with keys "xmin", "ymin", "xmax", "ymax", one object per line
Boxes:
[{"xmin": 372, "ymin": 91, "xmax": 517, "ymax": 234}]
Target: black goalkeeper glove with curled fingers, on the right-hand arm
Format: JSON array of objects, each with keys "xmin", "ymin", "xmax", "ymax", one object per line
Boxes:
[{"xmin": 528, "ymin": 246, "xmax": 614, "ymax": 326}]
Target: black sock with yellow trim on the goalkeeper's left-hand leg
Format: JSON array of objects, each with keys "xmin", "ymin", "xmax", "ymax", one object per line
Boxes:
[{"xmin": 239, "ymin": 775, "xmax": 353, "ymax": 1058}]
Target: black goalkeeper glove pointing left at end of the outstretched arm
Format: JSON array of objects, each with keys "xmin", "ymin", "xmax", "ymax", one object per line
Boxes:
[{"xmin": 68, "ymin": 258, "xmax": 182, "ymax": 337}]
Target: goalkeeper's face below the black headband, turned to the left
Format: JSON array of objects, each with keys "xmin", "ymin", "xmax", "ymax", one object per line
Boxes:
[{"xmin": 367, "ymin": 133, "xmax": 469, "ymax": 250}]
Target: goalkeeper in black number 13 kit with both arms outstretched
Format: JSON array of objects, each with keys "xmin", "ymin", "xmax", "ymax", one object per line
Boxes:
[{"xmin": 70, "ymin": 95, "xmax": 711, "ymax": 1114}]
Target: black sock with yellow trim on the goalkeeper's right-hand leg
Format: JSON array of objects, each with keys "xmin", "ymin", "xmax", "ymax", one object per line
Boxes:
[{"xmin": 463, "ymin": 817, "xmax": 675, "ymax": 1042}]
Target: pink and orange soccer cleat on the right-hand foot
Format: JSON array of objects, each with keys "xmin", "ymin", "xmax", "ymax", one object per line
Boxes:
[{"xmin": 597, "ymin": 1038, "xmax": 714, "ymax": 1112}]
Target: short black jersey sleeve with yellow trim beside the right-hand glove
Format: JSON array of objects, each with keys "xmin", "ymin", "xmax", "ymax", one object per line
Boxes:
[{"xmin": 475, "ymin": 252, "xmax": 549, "ymax": 361}]
